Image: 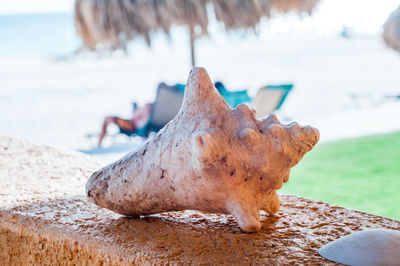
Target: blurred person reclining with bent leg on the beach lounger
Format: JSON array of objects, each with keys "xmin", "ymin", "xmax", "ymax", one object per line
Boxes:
[{"xmin": 97, "ymin": 103, "xmax": 151, "ymax": 147}]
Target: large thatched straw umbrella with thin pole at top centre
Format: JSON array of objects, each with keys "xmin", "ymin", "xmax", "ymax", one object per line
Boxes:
[{"xmin": 75, "ymin": 0, "xmax": 318, "ymax": 65}]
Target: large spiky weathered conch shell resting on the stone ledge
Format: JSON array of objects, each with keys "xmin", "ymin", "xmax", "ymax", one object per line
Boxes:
[{"xmin": 86, "ymin": 68, "xmax": 319, "ymax": 232}]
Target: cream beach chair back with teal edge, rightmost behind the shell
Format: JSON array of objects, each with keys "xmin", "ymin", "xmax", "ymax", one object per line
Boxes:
[{"xmin": 250, "ymin": 84, "xmax": 293, "ymax": 117}]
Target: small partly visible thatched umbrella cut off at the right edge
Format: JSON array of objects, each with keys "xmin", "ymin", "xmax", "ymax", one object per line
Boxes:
[{"xmin": 382, "ymin": 6, "xmax": 400, "ymax": 52}]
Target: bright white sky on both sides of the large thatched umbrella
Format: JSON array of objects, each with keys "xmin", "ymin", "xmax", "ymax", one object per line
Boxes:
[{"xmin": 0, "ymin": 0, "xmax": 400, "ymax": 33}]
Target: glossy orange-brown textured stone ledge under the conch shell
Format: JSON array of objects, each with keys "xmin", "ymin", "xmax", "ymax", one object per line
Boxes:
[{"xmin": 0, "ymin": 134, "xmax": 400, "ymax": 265}]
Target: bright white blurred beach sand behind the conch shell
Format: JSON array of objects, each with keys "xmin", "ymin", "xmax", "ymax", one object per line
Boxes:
[{"xmin": 0, "ymin": 34, "xmax": 400, "ymax": 162}]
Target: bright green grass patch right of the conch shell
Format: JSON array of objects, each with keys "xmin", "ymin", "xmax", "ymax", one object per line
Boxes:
[{"xmin": 280, "ymin": 133, "xmax": 400, "ymax": 220}]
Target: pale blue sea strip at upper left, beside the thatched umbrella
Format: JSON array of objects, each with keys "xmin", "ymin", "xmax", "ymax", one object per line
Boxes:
[{"xmin": 0, "ymin": 12, "xmax": 81, "ymax": 57}]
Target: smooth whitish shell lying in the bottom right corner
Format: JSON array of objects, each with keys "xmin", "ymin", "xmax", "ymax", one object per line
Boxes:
[{"xmin": 318, "ymin": 229, "xmax": 400, "ymax": 266}]
